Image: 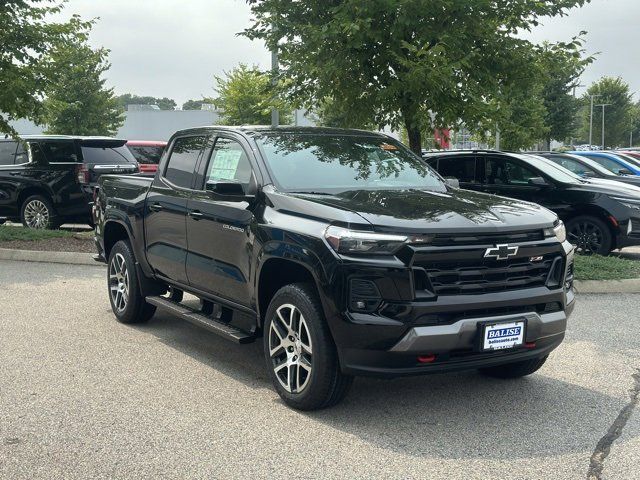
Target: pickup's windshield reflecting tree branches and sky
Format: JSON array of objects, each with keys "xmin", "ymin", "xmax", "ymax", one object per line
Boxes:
[{"xmin": 257, "ymin": 133, "xmax": 446, "ymax": 193}]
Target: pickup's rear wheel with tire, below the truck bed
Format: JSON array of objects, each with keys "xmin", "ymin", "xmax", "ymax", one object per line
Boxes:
[{"xmin": 107, "ymin": 240, "xmax": 156, "ymax": 323}]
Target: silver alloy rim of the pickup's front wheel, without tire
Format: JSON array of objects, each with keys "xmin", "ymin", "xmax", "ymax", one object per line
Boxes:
[{"xmin": 269, "ymin": 303, "xmax": 312, "ymax": 393}]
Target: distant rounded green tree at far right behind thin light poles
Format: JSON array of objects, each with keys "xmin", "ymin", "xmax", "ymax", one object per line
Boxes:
[{"xmin": 581, "ymin": 77, "xmax": 634, "ymax": 148}]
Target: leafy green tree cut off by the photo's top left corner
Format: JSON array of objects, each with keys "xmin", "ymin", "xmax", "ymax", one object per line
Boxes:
[{"xmin": 0, "ymin": 0, "xmax": 91, "ymax": 133}]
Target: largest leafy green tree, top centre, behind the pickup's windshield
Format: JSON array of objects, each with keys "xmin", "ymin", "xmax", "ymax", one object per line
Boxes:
[{"xmin": 243, "ymin": 0, "xmax": 585, "ymax": 152}]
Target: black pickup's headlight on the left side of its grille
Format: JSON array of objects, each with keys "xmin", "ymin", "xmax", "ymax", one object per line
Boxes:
[{"xmin": 324, "ymin": 226, "xmax": 409, "ymax": 255}]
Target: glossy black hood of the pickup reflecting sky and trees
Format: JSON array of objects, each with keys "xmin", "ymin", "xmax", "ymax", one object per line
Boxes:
[{"xmin": 268, "ymin": 188, "xmax": 557, "ymax": 233}]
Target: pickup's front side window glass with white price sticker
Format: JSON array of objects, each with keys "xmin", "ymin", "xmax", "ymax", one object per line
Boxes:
[{"xmin": 207, "ymin": 138, "xmax": 251, "ymax": 186}]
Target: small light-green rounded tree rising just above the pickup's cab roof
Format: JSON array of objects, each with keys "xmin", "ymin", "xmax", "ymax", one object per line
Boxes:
[{"xmin": 213, "ymin": 63, "xmax": 292, "ymax": 125}]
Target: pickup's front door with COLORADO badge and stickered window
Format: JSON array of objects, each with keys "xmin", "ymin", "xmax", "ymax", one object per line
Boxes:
[{"xmin": 187, "ymin": 136, "xmax": 257, "ymax": 306}]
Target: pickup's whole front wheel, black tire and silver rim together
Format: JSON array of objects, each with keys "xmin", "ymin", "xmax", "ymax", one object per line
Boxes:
[{"xmin": 264, "ymin": 283, "xmax": 353, "ymax": 410}]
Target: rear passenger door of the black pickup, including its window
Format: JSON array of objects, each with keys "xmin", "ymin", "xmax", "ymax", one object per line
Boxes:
[{"xmin": 144, "ymin": 135, "xmax": 208, "ymax": 284}]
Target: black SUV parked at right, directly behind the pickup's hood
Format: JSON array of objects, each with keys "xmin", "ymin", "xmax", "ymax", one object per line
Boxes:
[{"xmin": 424, "ymin": 150, "xmax": 640, "ymax": 255}]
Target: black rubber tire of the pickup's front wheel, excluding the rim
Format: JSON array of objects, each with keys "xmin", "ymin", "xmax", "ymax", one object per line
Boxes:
[{"xmin": 263, "ymin": 284, "xmax": 341, "ymax": 410}]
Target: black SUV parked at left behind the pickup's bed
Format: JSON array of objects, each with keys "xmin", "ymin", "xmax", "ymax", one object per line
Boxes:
[{"xmin": 0, "ymin": 135, "xmax": 138, "ymax": 228}]
